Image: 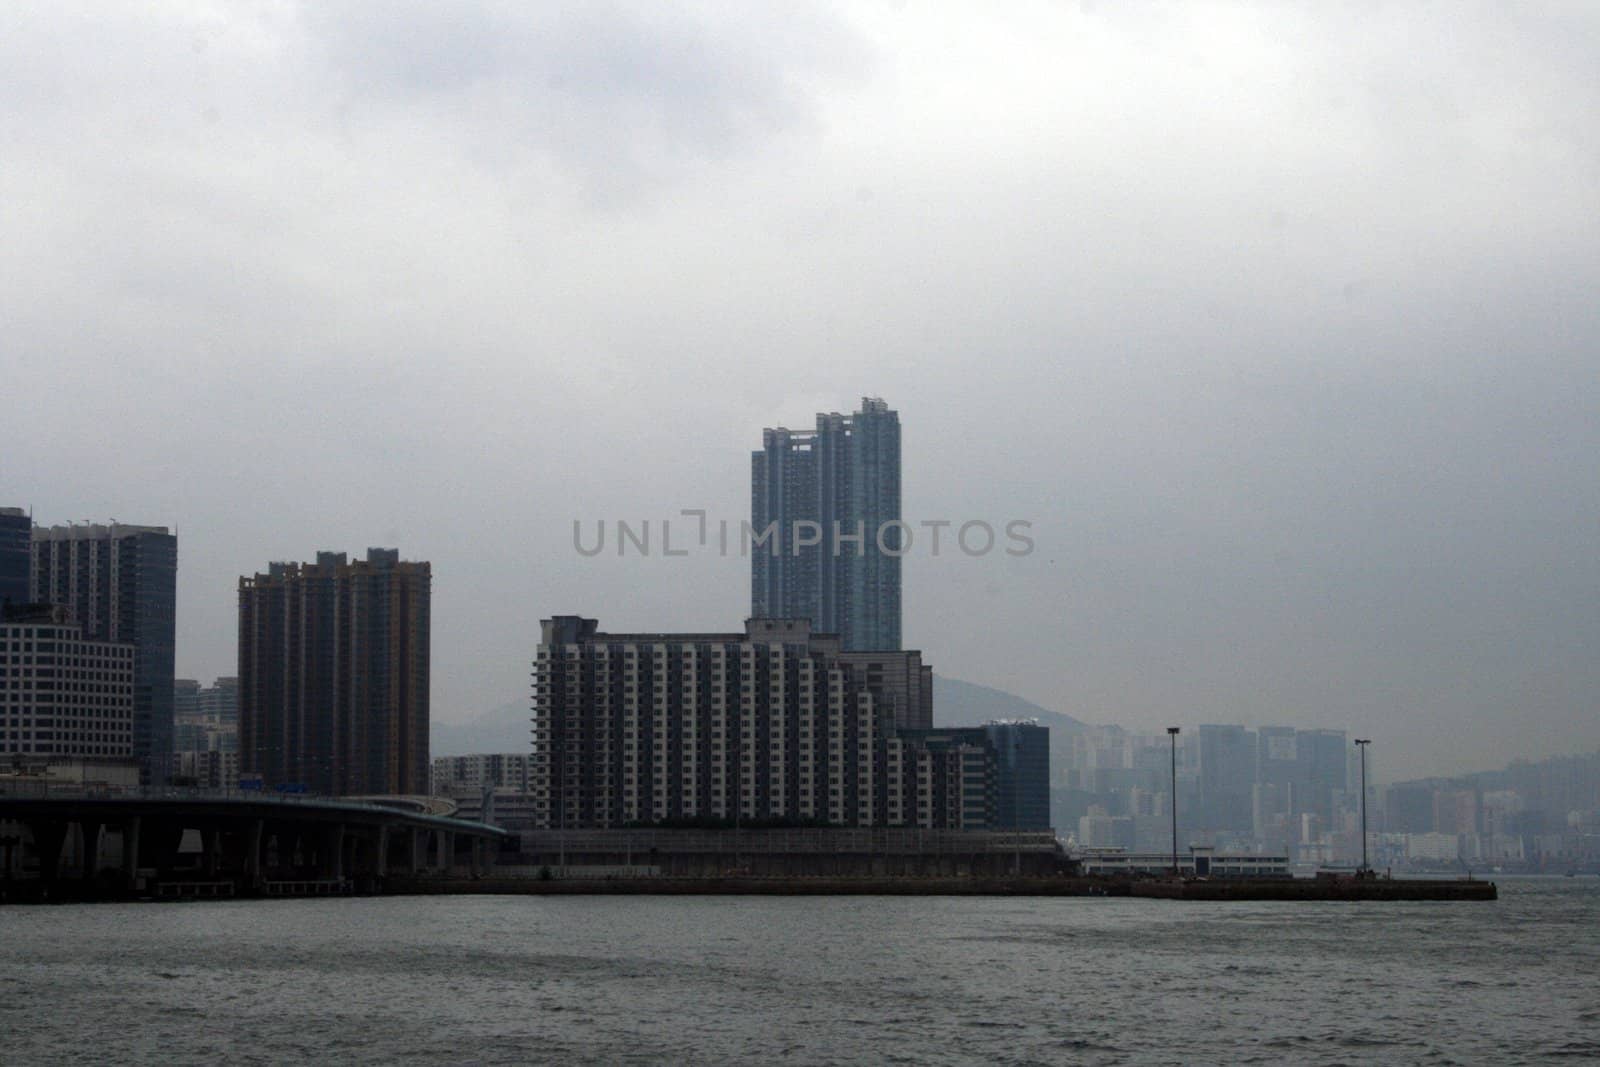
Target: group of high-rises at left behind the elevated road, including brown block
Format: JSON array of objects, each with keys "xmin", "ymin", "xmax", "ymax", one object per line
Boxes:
[{"xmin": 0, "ymin": 507, "xmax": 430, "ymax": 806}]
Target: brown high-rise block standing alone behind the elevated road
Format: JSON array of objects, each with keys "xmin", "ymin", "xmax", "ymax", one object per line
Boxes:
[{"xmin": 238, "ymin": 549, "xmax": 432, "ymax": 795}]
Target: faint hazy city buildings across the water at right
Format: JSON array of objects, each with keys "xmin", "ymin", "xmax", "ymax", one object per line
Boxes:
[{"xmin": 1054, "ymin": 725, "xmax": 1600, "ymax": 872}]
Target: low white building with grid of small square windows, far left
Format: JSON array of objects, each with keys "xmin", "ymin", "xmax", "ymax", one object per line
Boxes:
[{"xmin": 0, "ymin": 606, "xmax": 138, "ymax": 763}]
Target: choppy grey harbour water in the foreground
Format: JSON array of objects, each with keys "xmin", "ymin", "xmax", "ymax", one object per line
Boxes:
[{"xmin": 0, "ymin": 878, "xmax": 1600, "ymax": 1064}]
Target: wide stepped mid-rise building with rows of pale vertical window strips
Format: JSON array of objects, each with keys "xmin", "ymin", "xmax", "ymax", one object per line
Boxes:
[{"xmin": 530, "ymin": 616, "xmax": 995, "ymax": 829}]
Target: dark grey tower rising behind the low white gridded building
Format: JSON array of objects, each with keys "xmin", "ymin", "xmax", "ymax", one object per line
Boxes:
[{"xmin": 29, "ymin": 523, "xmax": 178, "ymax": 784}]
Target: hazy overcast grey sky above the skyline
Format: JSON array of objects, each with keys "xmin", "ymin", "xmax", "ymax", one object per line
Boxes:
[{"xmin": 0, "ymin": 2, "xmax": 1600, "ymax": 777}]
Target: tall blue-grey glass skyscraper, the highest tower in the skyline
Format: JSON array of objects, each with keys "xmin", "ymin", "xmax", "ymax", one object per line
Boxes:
[{"xmin": 750, "ymin": 397, "xmax": 902, "ymax": 651}]
